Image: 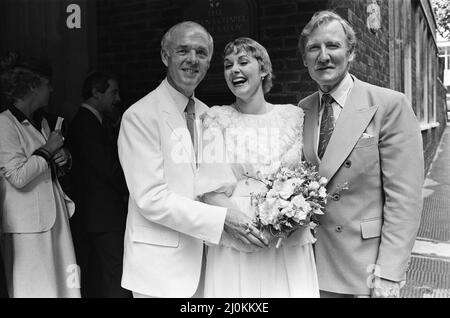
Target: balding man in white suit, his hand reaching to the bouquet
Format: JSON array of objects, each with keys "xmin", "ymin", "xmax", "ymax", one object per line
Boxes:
[{"xmin": 118, "ymin": 21, "xmax": 267, "ymax": 297}]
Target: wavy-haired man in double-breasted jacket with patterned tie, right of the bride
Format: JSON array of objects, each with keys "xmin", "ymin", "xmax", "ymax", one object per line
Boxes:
[{"xmin": 299, "ymin": 11, "xmax": 424, "ymax": 297}]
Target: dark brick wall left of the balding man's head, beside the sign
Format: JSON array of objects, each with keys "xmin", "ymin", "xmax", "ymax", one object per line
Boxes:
[{"xmin": 97, "ymin": 0, "xmax": 182, "ymax": 107}]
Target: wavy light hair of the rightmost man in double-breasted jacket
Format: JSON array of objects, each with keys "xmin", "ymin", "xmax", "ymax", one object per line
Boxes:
[{"xmin": 298, "ymin": 10, "xmax": 356, "ymax": 56}]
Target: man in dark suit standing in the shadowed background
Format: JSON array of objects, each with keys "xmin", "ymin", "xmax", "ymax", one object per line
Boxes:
[{"xmin": 67, "ymin": 71, "xmax": 131, "ymax": 298}]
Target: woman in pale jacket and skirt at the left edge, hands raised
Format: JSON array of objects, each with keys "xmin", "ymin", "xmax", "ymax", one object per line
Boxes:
[{"xmin": 0, "ymin": 55, "xmax": 80, "ymax": 298}]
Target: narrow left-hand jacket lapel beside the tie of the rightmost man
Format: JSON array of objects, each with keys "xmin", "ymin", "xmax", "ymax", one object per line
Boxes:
[{"xmin": 303, "ymin": 93, "xmax": 320, "ymax": 167}]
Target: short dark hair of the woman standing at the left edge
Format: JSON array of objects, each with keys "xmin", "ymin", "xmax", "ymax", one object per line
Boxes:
[{"xmin": 0, "ymin": 52, "xmax": 52, "ymax": 104}]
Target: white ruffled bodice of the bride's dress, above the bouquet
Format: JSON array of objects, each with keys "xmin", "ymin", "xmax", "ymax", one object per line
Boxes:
[{"xmin": 202, "ymin": 104, "xmax": 304, "ymax": 180}]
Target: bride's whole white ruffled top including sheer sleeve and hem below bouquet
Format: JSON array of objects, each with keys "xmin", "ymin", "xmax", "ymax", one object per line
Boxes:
[{"xmin": 196, "ymin": 105, "xmax": 314, "ymax": 252}]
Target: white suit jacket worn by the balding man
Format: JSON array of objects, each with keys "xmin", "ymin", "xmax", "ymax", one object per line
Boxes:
[{"xmin": 118, "ymin": 79, "xmax": 226, "ymax": 297}]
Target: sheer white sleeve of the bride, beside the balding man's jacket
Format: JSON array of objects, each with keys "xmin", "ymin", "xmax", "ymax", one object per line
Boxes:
[{"xmin": 195, "ymin": 107, "xmax": 237, "ymax": 197}]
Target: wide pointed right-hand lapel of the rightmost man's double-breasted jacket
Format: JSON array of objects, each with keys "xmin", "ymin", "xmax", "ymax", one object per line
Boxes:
[{"xmin": 319, "ymin": 78, "xmax": 378, "ymax": 180}]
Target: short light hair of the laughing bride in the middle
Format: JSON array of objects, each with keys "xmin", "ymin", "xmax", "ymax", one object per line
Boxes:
[{"xmin": 223, "ymin": 37, "xmax": 274, "ymax": 94}]
